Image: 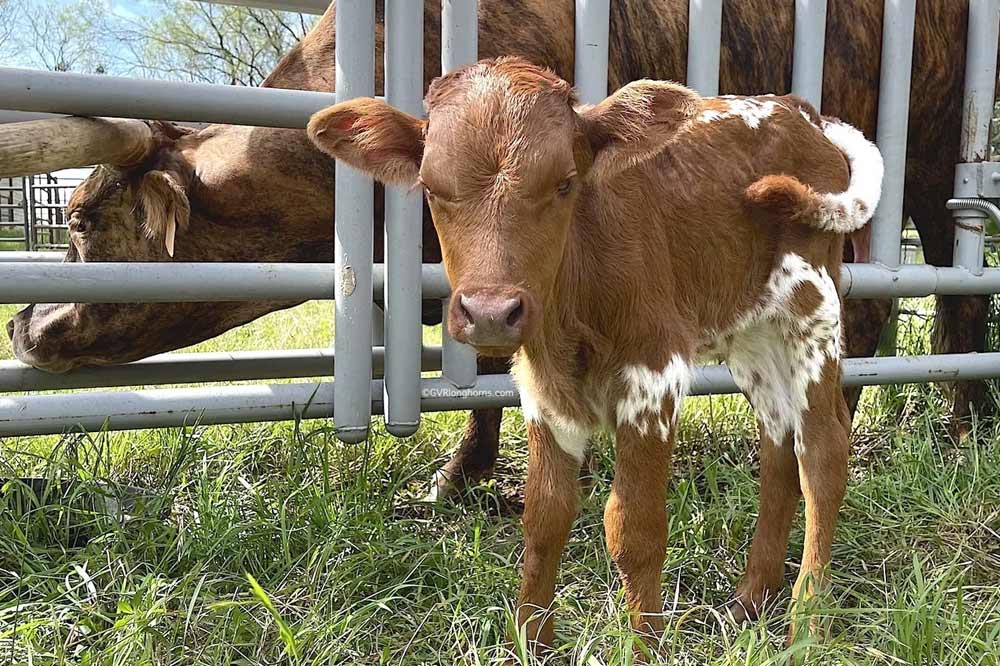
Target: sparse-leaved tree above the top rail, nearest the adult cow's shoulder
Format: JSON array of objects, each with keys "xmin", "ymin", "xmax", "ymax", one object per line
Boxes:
[{"xmin": 110, "ymin": 0, "xmax": 314, "ymax": 86}]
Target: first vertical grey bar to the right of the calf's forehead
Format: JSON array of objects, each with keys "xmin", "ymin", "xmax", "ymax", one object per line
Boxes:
[{"xmin": 573, "ymin": 0, "xmax": 611, "ymax": 104}]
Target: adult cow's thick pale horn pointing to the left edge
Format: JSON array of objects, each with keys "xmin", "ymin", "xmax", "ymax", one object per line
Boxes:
[{"xmin": 0, "ymin": 117, "xmax": 156, "ymax": 178}]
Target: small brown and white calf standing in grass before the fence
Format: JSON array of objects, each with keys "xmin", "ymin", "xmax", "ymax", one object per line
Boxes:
[{"xmin": 309, "ymin": 58, "xmax": 882, "ymax": 644}]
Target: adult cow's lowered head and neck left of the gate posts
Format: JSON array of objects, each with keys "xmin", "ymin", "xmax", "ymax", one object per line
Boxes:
[{"xmin": 0, "ymin": 118, "xmax": 332, "ymax": 372}]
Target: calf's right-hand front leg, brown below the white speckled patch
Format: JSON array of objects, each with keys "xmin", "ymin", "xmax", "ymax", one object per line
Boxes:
[{"xmin": 604, "ymin": 420, "xmax": 674, "ymax": 644}]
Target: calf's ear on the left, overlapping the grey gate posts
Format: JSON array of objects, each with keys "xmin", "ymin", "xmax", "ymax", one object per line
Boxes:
[{"xmin": 308, "ymin": 97, "xmax": 424, "ymax": 186}]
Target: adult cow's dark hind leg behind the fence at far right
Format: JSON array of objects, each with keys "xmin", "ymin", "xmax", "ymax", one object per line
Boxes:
[{"xmin": 908, "ymin": 193, "xmax": 991, "ymax": 436}]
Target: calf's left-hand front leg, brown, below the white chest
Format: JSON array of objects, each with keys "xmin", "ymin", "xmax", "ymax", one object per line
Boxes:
[{"xmin": 517, "ymin": 422, "xmax": 587, "ymax": 650}]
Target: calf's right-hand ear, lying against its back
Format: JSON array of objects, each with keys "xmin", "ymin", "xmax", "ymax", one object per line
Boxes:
[{"xmin": 580, "ymin": 81, "xmax": 701, "ymax": 179}]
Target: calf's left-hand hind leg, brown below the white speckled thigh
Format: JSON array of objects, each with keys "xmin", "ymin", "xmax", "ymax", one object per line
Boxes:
[{"xmin": 730, "ymin": 423, "xmax": 801, "ymax": 622}]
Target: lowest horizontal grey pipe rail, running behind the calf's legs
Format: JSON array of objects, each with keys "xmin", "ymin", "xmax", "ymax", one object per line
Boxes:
[{"xmin": 0, "ymin": 353, "xmax": 1000, "ymax": 437}]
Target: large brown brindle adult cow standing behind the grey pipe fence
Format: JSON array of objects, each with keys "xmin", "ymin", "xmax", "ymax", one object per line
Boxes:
[{"xmin": 0, "ymin": 0, "xmax": 987, "ymax": 498}]
